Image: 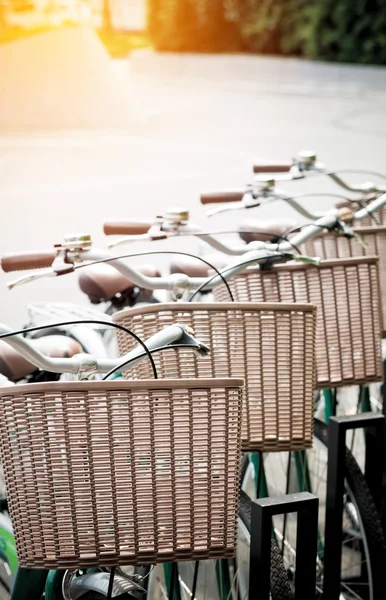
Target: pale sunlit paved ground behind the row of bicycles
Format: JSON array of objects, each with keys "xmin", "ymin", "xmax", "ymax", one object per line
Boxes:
[{"xmin": 0, "ymin": 53, "xmax": 386, "ymax": 325}]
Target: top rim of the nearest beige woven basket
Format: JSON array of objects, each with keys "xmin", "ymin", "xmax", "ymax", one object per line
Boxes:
[{"xmin": 0, "ymin": 377, "xmax": 245, "ymax": 399}]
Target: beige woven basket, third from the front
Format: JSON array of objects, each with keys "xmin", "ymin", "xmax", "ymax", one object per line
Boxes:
[{"xmin": 214, "ymin": 257, "xmax": 382, "ymax": 388}]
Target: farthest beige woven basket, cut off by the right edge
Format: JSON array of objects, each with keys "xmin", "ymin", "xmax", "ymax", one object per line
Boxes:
[{"xmin": 302, "ymin": 225, "xmax": 386, "ymax": 337}]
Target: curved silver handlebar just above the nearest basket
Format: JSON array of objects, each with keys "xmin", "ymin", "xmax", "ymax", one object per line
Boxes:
[{"xmin": 0, "ymin": 323, "xmax": 209, "ymax": 378}]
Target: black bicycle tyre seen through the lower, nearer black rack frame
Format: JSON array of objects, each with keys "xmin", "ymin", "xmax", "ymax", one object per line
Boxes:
[{"xmin": 239, "ymin": 490, "xmax": 294, "ymax": 600}]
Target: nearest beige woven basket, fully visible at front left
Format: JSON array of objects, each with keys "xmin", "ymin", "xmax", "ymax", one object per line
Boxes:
[{"xmin": 0, "ymin": 379, "xmax": 243, "ymax": 569}]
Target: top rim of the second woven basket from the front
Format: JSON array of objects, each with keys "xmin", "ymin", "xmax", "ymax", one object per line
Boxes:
[{"xmin": 113, "ymin": 302, "xmax": 317, "ymax": 322}]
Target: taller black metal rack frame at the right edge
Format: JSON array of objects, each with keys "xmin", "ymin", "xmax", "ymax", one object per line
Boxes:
[{"xmin": 323, "ymin": 413, "xmax": 385, "ymax": 600}]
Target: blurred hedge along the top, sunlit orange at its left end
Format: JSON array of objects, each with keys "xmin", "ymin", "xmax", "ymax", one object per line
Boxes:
[{"xmin": 148, "ymin": 0, "xmax": 386, "ymax": 64}]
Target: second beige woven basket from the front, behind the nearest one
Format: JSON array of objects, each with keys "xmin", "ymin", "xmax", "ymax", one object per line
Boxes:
[{"xmin": 114, "ymin": 303, "xmax": 316, "ymax": 451}]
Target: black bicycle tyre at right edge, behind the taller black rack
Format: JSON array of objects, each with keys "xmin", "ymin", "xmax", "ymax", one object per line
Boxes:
[{"xmin": 314, "ymin": 419, "xmax": 386, "ymax": 600}]
